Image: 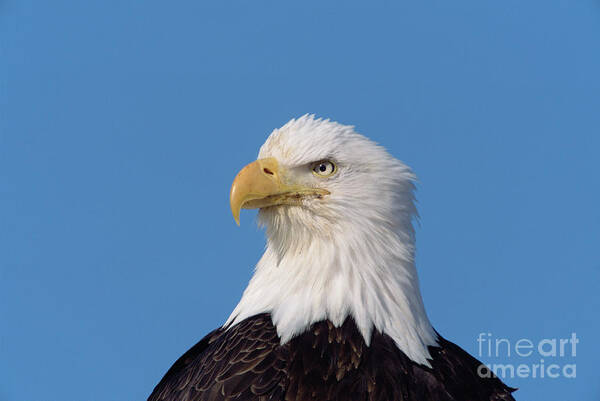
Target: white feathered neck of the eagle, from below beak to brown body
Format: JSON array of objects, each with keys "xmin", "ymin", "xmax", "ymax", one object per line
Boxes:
[{"xmin": 226, "ymin": 219, "xmax": 437, "ymax": 366}]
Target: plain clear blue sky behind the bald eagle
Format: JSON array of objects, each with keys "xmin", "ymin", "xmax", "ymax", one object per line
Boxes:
[{"xmin": 0, "ymin": 0, "xmax": 600, "ymax": 401}]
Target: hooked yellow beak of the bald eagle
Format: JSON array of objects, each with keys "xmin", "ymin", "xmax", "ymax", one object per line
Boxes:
[{"xmin": 229, "ymin": 157, "xmax": 329, "ymax": 226}]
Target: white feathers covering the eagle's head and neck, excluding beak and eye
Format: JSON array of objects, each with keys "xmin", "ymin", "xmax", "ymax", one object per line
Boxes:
[{"xmin": 226, "ymin": 115, "xmax": 436, "ymax": 365}]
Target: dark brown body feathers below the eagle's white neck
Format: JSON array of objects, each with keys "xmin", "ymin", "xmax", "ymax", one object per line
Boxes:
[{"xmin": 148, "ymin": 314, "xmax": 514, "ymax": 401}]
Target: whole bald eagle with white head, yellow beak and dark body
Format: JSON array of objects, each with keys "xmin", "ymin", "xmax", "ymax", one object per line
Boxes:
[{"xmin": 148, "ymin": 115, "xmax": 514, "ymax": 401}]
